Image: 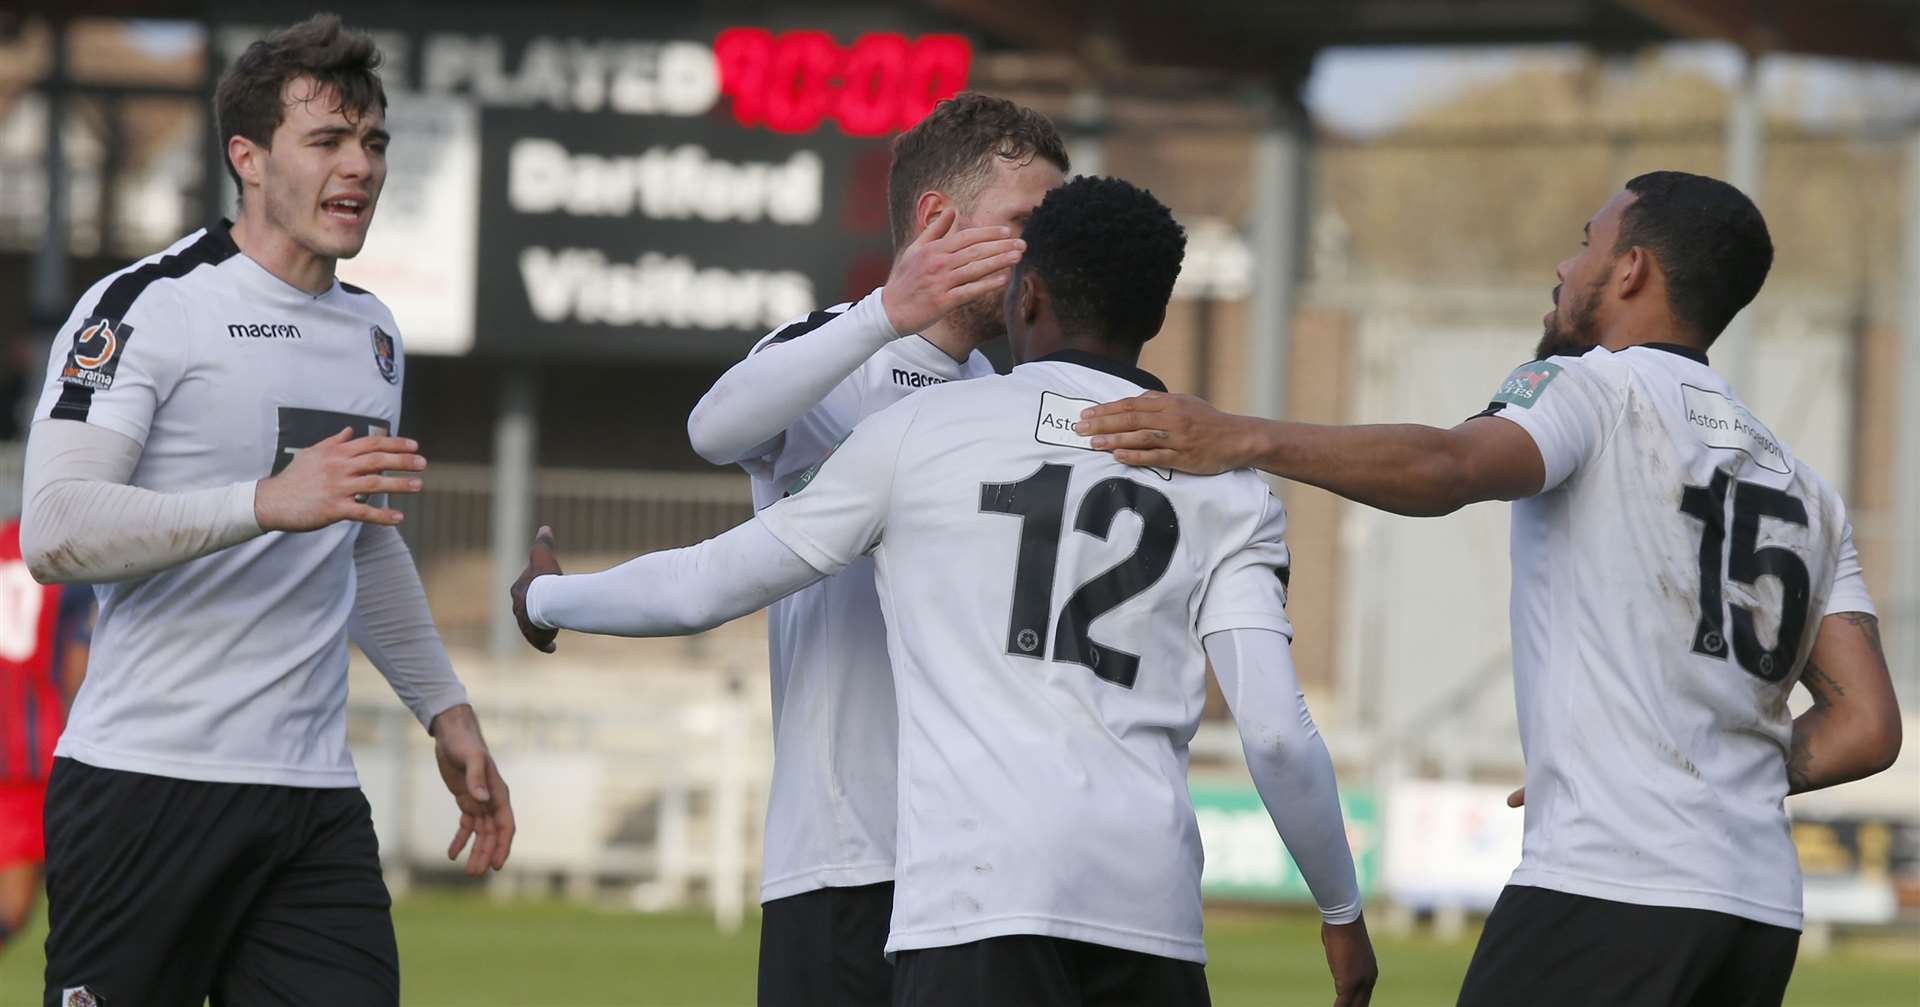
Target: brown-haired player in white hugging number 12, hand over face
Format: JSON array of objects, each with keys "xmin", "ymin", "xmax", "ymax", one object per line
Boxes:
[{"xmin": 687, "ymin": 94, "xmax": 1068, "ymax": 1007}]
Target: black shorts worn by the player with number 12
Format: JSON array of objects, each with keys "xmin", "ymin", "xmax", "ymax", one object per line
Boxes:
[{"xmin": 893, "ymin": 934, "xmax": 1210, "ymax": 1007}]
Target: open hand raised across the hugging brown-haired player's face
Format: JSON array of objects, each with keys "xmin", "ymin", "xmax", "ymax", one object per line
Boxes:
[{"xmin": 879, "ymin": 209, "xmax": 1027, "ymax": 336}]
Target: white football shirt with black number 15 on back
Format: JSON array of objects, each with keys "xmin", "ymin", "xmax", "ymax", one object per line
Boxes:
[{"xmin": 1490, "ymin": 346, "xmax": 1874, "ymax": 928}]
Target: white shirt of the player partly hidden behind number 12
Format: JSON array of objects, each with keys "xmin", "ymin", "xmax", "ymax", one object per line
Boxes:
[{"xmin": 741, "ymin": 300, "xmax": 993, "ymax": 901}]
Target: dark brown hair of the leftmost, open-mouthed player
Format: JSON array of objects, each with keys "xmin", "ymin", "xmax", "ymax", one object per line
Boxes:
[{"xmin": 213, "ymin": 13, "xmax": 386, "ymax": 192}]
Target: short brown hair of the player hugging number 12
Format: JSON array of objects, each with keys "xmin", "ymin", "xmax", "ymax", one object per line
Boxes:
[{"xmin": 887, "ymin": 90, "xmax": 1068, "ymax": 250}]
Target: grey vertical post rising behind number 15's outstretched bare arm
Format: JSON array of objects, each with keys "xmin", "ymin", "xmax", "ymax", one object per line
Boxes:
[{"xmin": 1246, "ymin": 81, "xmax": 1313, "ymax": 419}]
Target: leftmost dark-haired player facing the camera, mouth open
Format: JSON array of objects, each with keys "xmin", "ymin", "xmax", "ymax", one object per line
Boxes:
[{"xmin": 21, "ymin": 15, "xmax": 513, "ymax": 1007}]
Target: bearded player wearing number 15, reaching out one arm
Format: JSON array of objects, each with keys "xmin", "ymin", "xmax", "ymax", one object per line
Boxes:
[{"xmin": 1085, "ymin": 171, "xmax": 1901, "ymax": 1007}]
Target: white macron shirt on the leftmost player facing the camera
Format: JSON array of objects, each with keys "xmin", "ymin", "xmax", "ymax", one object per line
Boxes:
[{"xmin": 35, "ymin": 225, "xmax": 405, "ymax": 788}]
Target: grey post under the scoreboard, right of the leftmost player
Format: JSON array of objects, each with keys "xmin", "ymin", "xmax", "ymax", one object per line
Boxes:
[{"xmin": 488, "ymin": 361, "xmax": 540, "ymax": 661}]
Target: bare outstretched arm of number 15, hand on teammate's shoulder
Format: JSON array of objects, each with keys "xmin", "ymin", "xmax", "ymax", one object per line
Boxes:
[{"xmin": 1073, "ymin": 392, "xmax": 1546, "ymax": 517}]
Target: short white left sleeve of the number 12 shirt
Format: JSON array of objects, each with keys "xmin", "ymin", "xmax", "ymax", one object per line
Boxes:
[{"xmin": 760, "ymin": 396, "xmax": 925, "ymax": 575}]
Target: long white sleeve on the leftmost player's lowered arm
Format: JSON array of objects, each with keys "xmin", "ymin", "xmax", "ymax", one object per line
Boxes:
[{"xmin": 348, "ymin": 525, "xmax": 467, "ymax": 726}]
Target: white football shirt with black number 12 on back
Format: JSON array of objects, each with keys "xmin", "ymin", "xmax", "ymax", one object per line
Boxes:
[{"xmin": 760, "ymin": 352, "xmax": 1292, "ymax": 961}]
